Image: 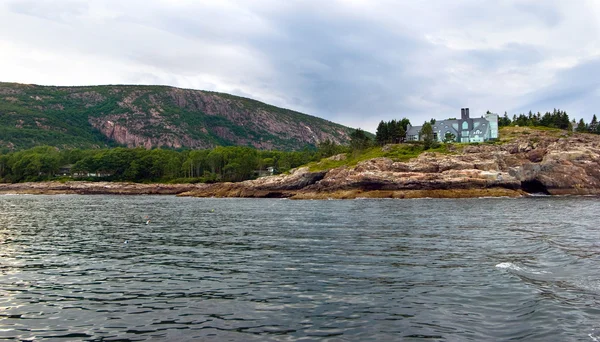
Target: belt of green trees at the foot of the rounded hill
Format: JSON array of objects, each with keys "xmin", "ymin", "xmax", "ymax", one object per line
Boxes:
[{"xmin": 0, "ymin": 140, "xmax": 349, "ymax": 183}]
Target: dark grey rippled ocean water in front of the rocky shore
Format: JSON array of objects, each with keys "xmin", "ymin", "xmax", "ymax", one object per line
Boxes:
[{"xmin": 0, "ymin": 195, "xmax": 600, "ymax": 341}]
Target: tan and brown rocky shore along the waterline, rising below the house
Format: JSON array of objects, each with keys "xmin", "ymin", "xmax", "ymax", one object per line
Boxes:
[{"xmin": 0, "ymin": 128, "xmax": 600, "ymax": 199}]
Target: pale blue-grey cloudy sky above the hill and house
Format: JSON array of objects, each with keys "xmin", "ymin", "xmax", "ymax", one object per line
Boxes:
[{"xmin": 0, "ymin": 0, "xmax": 600, "ymax": 132}]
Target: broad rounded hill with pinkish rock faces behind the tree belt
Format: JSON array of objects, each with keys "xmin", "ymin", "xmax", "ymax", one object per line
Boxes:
[{"xmin": 0, "ymin": 82, "xmax": 352, "ymax": 150}]
